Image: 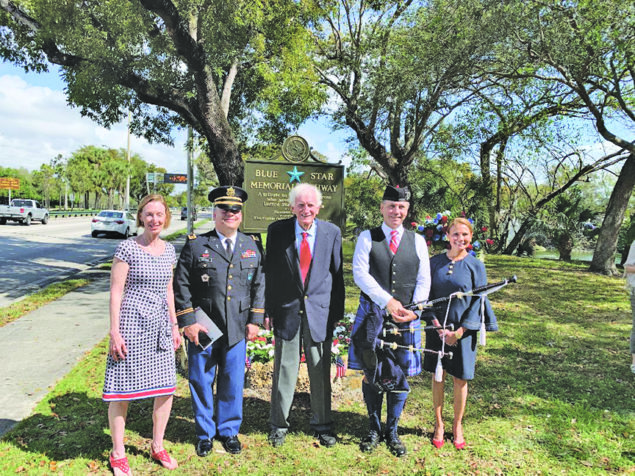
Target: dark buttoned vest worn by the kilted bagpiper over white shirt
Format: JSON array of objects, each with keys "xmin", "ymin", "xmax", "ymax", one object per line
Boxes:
[{"xmin": 368, "ymin": 227, "xmax": 419, "ymax": 304}]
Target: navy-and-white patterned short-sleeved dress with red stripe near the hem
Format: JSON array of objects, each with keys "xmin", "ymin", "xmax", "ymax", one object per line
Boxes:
[{"xmin": 102, "ymin": 238, "xmax": 176, "ymax": 402}]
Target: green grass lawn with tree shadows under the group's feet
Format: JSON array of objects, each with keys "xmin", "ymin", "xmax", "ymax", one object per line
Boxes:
[{"xmin": 0, "ymin": 253, "xmax": 635, "ymax": 475}]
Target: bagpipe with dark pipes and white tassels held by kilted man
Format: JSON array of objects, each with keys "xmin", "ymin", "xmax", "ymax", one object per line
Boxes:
[{"xmin": 376, "ymin": 276, "xmax": 517, "ymax": 382}]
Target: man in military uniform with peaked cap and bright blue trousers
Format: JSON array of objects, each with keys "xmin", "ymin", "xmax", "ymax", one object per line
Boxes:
[{"xmin": 174, "ymin": 186, "xmax": 264, "ymax": 456}]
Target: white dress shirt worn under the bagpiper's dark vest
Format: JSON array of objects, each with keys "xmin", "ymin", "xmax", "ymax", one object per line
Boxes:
[{"xmin": 353, "ymin": 223, "xmax": 430, "ymax": 308}]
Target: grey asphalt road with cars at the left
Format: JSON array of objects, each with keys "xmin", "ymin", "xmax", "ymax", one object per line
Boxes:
[{"xmin": 0, "ymin": 215, "xmax": 211, "ymax": 307}]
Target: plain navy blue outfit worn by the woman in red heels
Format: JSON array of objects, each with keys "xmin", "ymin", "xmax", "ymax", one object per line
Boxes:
[{"xmin": 423, "ymin": 253, "xmax": 498, "ymax": 380}]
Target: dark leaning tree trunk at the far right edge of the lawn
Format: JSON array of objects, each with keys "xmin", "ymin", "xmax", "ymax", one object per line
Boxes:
[{"xmin": 589, "ymin": 154, "xmax": 635, "ymax": 275}]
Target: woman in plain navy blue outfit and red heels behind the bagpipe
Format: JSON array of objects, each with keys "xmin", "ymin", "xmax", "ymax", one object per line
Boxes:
[{"xmin": 423, "ymin": 218, "xmax": 498, "ymax": 450}]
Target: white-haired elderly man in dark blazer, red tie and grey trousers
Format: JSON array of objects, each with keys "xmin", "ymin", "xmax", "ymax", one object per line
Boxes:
[{"xmin": 265, "ymin": 184, "xmax": 344, "ymax": 447}]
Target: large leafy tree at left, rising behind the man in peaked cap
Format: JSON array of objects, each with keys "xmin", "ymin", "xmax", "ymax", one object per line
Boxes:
[{"xmin": 0, "ymin": 0, "xmax": 325, "ymax": 184}]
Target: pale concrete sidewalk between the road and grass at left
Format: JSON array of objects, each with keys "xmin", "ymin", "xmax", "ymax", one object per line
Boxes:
[{"xmin": 0, "ymin": 237, "xmax": 185, "ymax": 436}]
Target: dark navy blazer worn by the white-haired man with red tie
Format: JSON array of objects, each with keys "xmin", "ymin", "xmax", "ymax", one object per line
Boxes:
[{"xmin": 265, "ymin": 217, "xmax": 344, "ymax": 342}]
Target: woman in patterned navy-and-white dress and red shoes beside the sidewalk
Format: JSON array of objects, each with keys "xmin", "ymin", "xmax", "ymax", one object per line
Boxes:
[{"xmin": 102, "ymin": 195, "xmax": 181, "ymax": 476}]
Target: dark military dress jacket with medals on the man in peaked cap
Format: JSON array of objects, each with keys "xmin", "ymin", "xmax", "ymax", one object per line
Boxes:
[{"xmin": 174, "ymin": 230, "xmax": 265, "ymax": 346}]
